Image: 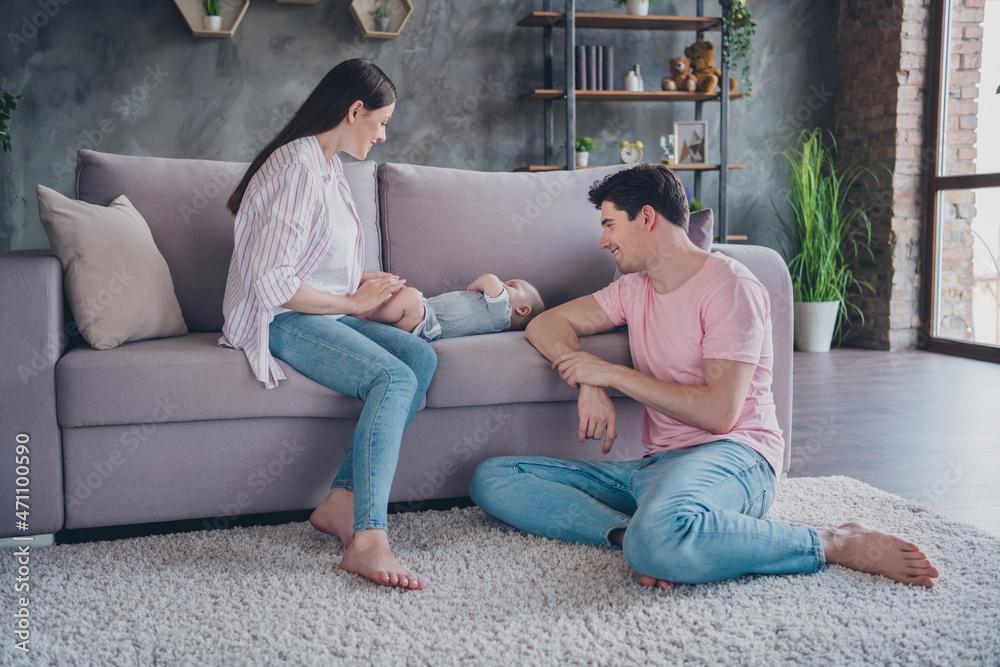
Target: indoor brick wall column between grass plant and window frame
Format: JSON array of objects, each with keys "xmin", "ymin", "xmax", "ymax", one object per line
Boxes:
[{"xmin": 835, "ymin": 0, "xmax": 930, "ymax": 349}]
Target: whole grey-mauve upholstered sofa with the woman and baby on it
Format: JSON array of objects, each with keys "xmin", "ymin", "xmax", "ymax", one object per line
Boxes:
[{"xmin": 0, "ymin": 150, "xmax": 792, "ymax": 536}]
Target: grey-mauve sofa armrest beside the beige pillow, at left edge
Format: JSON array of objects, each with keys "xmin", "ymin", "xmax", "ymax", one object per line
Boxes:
[{"xmin": 0, "ymin": 250, "xmax": 69, "ymax": 537}]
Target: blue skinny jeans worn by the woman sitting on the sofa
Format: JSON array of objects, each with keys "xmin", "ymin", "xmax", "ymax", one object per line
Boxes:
[{"xmin": 270, "ymin": 312, "xmax": 437, "ymax": 532}]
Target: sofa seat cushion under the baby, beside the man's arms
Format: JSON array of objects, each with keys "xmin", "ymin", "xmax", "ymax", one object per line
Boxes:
[{"xmin": 427, "ymin": 330, "xmax": 632, "ymax": 408}]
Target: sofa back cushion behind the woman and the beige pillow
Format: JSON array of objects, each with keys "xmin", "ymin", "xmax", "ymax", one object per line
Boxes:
[{"xmin": 76, "ymin": 150, "xmax": 381, "ymax": 331}]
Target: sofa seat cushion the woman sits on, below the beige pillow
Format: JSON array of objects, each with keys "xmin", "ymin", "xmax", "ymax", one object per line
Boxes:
[{"xmin": 56, "ymin": 333, "xmax": 362, "ymax": 429}]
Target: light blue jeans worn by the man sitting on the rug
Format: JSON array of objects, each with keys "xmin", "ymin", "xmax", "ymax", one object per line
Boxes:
[{"xmin": 470, "ymin": 440, "xmax": 825, "ymax": 584}]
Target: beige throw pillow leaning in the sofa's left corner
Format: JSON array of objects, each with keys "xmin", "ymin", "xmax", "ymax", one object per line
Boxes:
[{"xmin": 37, "ymin": 185, "xmax": 187, "ymax": 350}]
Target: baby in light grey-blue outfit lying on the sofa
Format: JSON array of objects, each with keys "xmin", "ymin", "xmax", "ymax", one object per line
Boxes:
[{"xmin": 361, "ymin": 273, "xmax": 545, "ymax": 340}]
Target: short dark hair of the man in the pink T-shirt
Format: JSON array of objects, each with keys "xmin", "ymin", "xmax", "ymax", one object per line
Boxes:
[{"xmin": 590, "ymin": 162, "xmax": 689, "ymax": 231}]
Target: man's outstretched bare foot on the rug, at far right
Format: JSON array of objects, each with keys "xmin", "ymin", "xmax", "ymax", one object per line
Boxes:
[{"xmin": 819, "ymin": 523, "xmax": 938, "ymax": 588}]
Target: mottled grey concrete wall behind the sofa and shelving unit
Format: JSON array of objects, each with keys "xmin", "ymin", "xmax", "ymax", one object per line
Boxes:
[{"xmin": 0, "ymin": 0, "xmax": 837, "ymax": 250}]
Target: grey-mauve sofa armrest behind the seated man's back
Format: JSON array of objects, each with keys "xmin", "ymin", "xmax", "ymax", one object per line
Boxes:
[{"xmin": 712, "ymin": 244, "xmax": 794, "ymax": 474}]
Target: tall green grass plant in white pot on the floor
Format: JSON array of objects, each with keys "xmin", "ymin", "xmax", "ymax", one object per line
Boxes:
[{"xmin": 777, "ymin": 128, "xmax": 875, "ymax": 352}]
